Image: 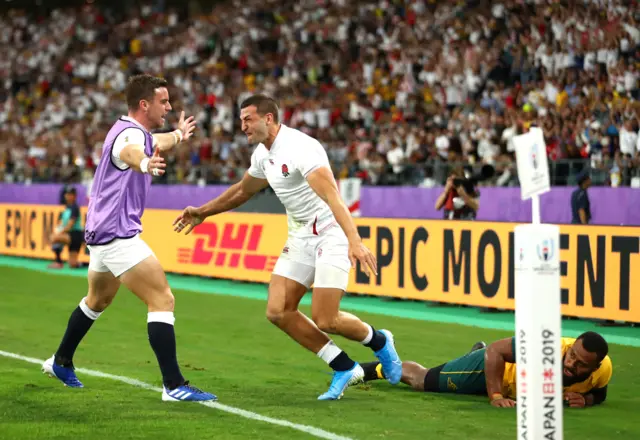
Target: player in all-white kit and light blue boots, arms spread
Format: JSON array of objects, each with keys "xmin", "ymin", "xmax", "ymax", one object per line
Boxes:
[{"xmin": 174, "ymin": 95, "xmax": 402, "ymax": 400}]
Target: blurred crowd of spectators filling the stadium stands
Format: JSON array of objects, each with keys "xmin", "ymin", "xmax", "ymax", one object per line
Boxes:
[{"xmin": 0, "ymin": 0, "xmax": 640, "ymax": 186}]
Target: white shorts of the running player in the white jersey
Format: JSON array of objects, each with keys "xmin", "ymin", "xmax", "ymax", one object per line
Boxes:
[{"xmin": 273, "ymin": 225, "xmax": 351, "ymax": 291}]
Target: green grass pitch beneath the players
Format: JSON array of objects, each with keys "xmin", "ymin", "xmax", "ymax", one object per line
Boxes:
[{"xmin": 0, "ymin": 267, "xmax": 640, "ymax": 440}]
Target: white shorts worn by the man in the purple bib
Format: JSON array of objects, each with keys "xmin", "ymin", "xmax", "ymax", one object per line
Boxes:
[{"xmin": 87, "ymin": 235, "xmax": 155, "ymax": 277}]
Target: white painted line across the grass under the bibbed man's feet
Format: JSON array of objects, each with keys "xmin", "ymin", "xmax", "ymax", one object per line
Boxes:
[{"xmin": 0, "ymin": 350, "xmax": 353, "ymax": 440}]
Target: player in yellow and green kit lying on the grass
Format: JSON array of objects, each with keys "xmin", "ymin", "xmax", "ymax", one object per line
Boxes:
[{"xmin": 362, "ymin": 332, "xmax": 613, "ymax": 408}]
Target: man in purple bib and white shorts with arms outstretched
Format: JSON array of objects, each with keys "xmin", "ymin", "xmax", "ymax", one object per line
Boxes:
[{"xmin": 42, "ymin": 75, "xmax": 217, "ymax": 401}]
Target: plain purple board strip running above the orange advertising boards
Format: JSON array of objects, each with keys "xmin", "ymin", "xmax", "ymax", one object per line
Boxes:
[{"xmin": 0, "ymin": 183, "xmax": 640, "ymax": 226}]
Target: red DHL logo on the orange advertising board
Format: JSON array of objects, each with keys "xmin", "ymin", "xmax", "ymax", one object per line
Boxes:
[{"xmin": 178, "ymin": 223, "xmax": 278, "ymax": 271}]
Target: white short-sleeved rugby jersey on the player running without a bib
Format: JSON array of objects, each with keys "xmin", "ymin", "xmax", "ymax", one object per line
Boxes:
[{"xmin": 248, "ymin": 124, "xmax": 336, "ymax": 234}]
